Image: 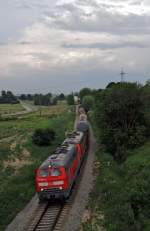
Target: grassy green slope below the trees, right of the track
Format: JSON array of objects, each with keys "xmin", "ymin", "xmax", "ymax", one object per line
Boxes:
[{"xmin": 82, "ymin": 138, "xmax": 150, "ymax": 231}]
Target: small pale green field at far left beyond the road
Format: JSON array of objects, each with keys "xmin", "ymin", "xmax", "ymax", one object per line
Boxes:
[{"xmin": 0, "ymin": 103, "xmax": 24, "ymax": 114}]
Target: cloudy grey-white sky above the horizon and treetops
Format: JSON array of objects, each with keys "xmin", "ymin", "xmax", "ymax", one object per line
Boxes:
[{"xmin": 0, "ymin": 0, "xmax": 150, "ymax": 93}]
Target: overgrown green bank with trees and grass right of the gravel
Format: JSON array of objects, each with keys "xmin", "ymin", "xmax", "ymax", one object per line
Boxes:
[{"xmin": 82, "ymin": 83, "xmax": 150, "ymax": 231}]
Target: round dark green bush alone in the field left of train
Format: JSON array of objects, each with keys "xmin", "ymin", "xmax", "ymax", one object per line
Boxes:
[{"xmin": 32, "ymin": 128, "xmax": 55, "ymax": 146}]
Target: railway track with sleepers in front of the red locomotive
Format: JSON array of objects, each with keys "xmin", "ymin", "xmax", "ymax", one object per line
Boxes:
[{"xmin": 27, "ymin": 148, "xmax": 87, "ymax": 231}]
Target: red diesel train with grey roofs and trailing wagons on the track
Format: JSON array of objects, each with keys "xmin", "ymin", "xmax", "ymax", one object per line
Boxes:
[{"xmin": 35, "ymin": 107, "xmax": 89, "ymax": 201}]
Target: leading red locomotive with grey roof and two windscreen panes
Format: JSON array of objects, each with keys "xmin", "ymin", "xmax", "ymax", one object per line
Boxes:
[{"xmin": 35, "ymin": 144, "xmax": 77, "ymax": 200}]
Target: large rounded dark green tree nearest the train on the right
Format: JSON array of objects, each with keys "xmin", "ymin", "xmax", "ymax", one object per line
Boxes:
[{"xmin": 95, "ymin": 83, "xmax": 146, "ymax": 161}]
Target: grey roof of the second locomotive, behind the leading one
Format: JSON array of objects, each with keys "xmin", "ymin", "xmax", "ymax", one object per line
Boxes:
[{"xmin": 64, "ymin": 131, "xmax": 84, "ymax": 144}]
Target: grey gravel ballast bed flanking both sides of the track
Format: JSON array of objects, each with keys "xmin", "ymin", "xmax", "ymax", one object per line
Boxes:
[{"xmin": 6, "ymin": 106, "xmax": 95, "ymax": 231}]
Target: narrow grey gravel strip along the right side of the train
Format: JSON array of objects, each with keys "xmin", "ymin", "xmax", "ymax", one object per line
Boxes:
[{"xmin": 63, "ymin": 124, "xmax": 96, "ymax": 231}]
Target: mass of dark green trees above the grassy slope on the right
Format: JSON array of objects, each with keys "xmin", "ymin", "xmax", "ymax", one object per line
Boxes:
[{"xmin": 79, "ymin": 81, "xmax": 150, "ymax": 162}]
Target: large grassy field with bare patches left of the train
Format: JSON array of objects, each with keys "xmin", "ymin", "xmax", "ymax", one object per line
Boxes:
[{"xmin": 0, "ymin": 106, "xmax": 74, "ymax": 230}]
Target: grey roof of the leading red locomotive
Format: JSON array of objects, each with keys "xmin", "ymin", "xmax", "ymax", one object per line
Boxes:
[{"xmin": 40, "ymin": 144, "xmax": 76, "ymax": 168}]
